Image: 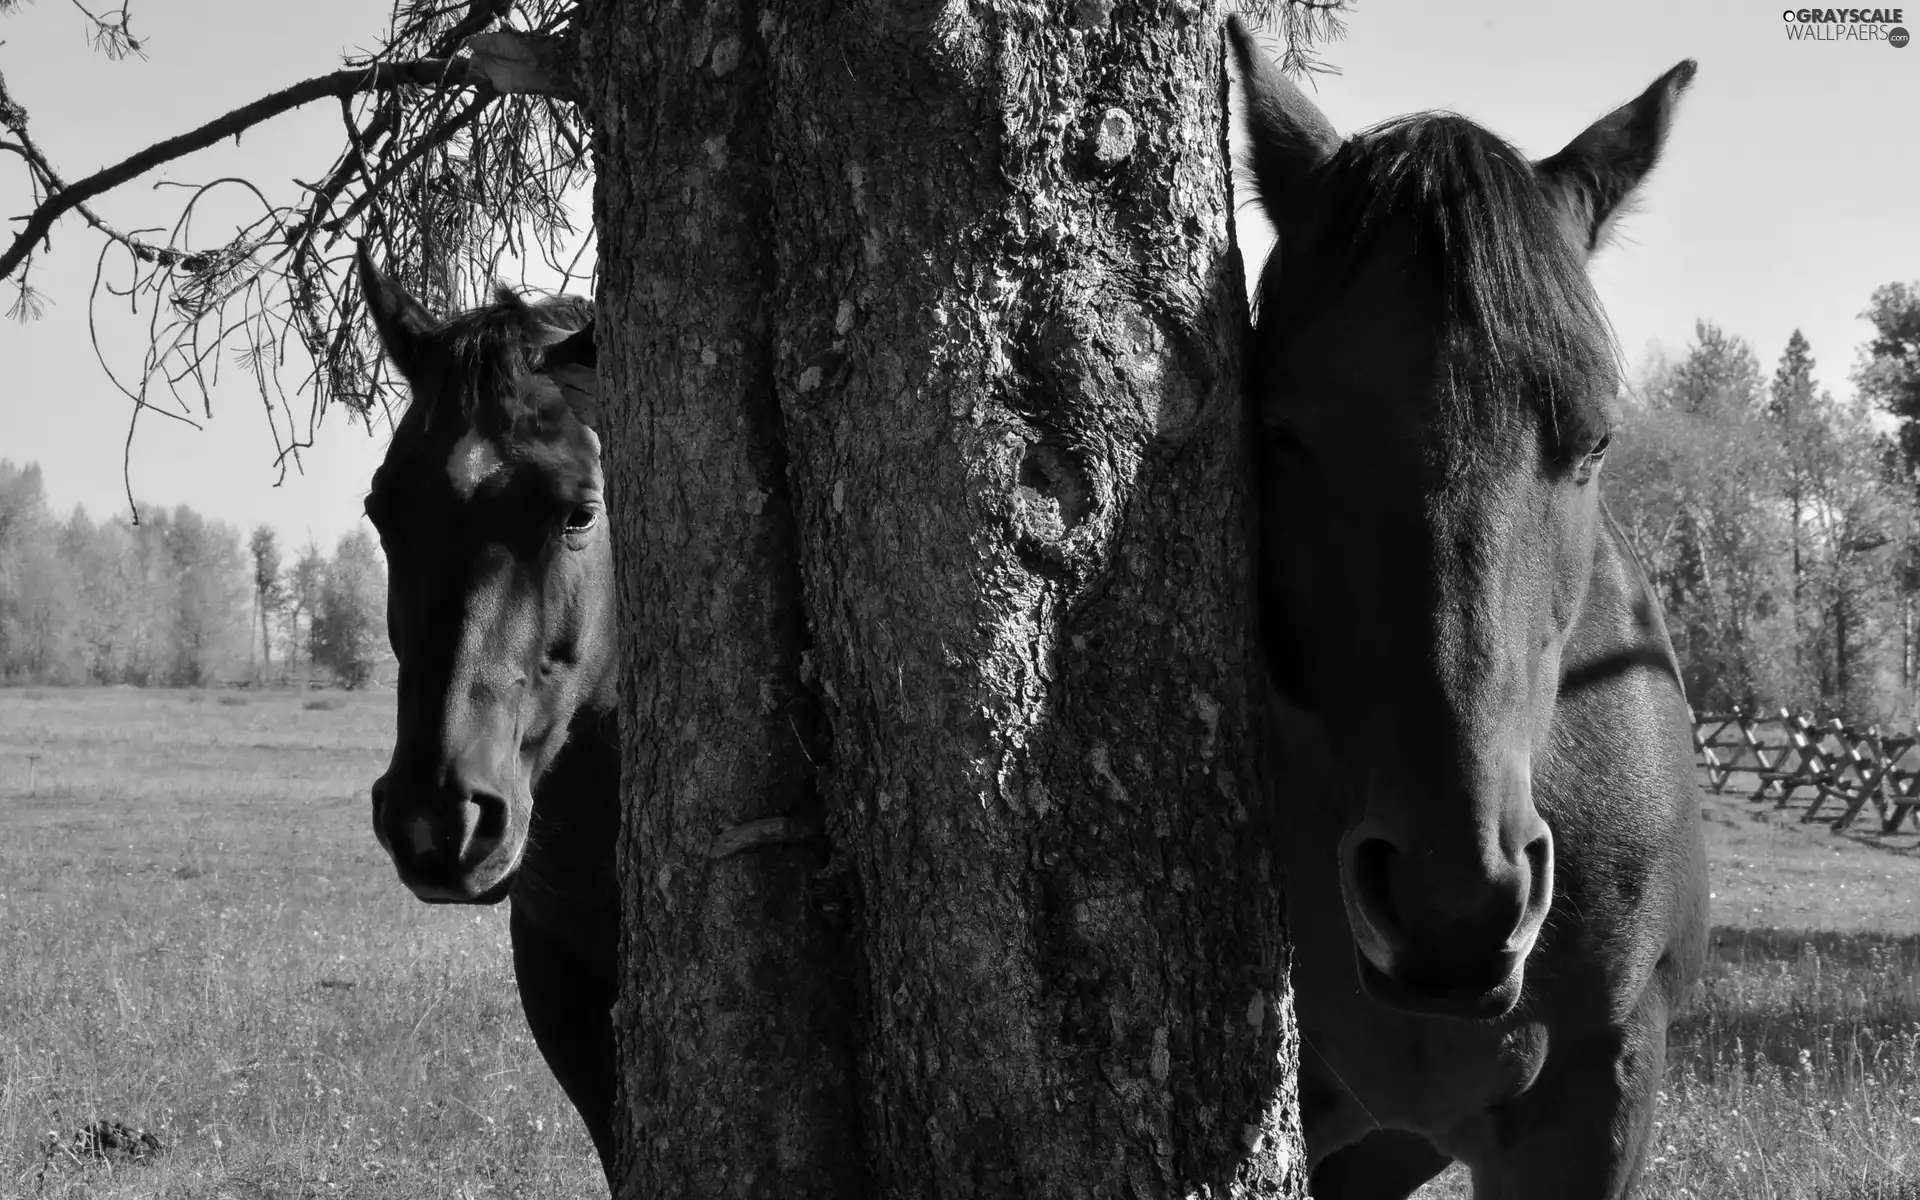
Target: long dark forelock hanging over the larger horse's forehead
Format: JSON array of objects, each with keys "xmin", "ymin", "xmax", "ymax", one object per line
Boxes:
[{"xmin": 1260, "ymin": 111, "xmax": 1620, "ymax": 447}]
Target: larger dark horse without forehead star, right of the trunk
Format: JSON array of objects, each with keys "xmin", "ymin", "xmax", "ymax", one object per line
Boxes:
[{"xmin": 1233, "ymin": 21, "xmax": 1707, "ymax": 1200}]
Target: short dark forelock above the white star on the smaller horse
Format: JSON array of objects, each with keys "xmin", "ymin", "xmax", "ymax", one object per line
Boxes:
[{"xmin": 399, "ymin": 284, "xmax": 593, "ymax": 434}]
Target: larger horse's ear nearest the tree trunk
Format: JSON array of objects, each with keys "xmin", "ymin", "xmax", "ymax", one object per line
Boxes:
[{"xmin": 1227, "ymin": 13, "xmax": 1340, "ymax": 244}]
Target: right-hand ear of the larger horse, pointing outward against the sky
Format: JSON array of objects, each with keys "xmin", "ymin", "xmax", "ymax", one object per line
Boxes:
[{"xmin": 1536, "ymin": 58, "xmax": 1699, "ymax": 253}]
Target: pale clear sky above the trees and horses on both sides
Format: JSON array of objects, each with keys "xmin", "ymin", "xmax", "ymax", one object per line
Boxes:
[{"xmin": 0, "ymin": 0, "xmax": 1920, "ymax": 545}]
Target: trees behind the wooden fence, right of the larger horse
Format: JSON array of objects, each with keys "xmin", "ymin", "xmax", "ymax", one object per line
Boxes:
[{"xmin": 1607, "ymin": 282, "xmax": 1920, "ymax": 724}]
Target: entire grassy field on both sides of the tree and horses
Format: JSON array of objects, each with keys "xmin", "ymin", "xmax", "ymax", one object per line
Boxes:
[{"xmin": 11, "ymin": 689, "xmax": 1920, "ymax": 1200}]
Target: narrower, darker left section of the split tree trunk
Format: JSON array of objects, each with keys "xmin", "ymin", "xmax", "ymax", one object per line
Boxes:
[{"xmin": 588, "ymin": 4, "xmax": 864, "ymax": 1200}]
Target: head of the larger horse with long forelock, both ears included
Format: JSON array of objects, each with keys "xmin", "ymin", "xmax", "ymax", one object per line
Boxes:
[{"xmin": 1233, "ymin": 21, "xmax": 1693, "ymax": 1018}]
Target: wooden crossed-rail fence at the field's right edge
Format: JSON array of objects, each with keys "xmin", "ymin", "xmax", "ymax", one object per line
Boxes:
[{"xmin": 1693, "ymin": 708, "xmax": 1920, "ymax": 833}]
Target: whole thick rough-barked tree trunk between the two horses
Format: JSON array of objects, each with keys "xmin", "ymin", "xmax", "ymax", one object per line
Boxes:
[{"xmin": 584, "ymin": 0, "xmax": 1304, "ymax": 1200}]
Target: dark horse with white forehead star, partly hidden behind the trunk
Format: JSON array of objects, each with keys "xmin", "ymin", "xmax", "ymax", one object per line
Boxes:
[{"xmin": 347, "ymin": 250, "xmax": 620, "ymax": 1181}]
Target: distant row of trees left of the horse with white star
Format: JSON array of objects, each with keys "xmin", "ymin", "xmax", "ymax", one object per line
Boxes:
[{"xmin": 0, "ymin": 459, "xmax": 390, "ymax": 687}]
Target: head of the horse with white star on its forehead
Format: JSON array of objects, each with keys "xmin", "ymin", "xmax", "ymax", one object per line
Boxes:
[{"xmin": 359, "ymin": 248, "xmax": 616, "ymax": 902}]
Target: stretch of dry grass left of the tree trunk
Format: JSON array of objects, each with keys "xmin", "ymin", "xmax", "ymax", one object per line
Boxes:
[{"xmin": 0, "ymin": 689, "xmax": 605, "ymax": 1200}]
